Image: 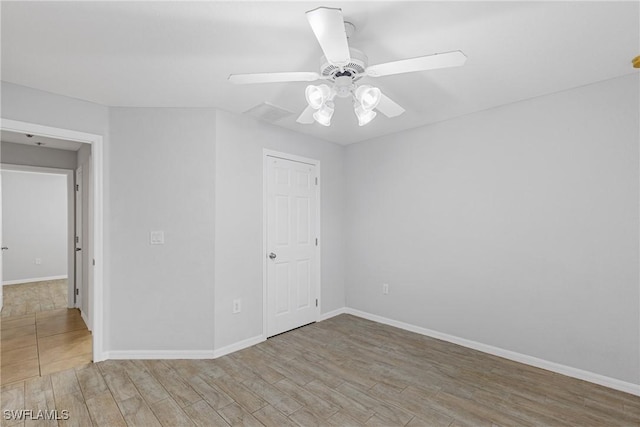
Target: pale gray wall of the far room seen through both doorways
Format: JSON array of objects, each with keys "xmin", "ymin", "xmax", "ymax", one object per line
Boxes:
[{"xmin": 2, "ymin": 170, "xmax": 68, "ymax": 282}]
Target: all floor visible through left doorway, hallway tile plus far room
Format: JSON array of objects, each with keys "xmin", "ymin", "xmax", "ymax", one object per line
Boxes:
[{"xmin": 0, "ymin": 280, "xmax": 92, "ymax": 385}]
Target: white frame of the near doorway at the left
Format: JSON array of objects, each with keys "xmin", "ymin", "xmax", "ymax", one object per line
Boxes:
[{"xmin": 0, "ymin": 118, "xmax": 106, "ymax": 362}]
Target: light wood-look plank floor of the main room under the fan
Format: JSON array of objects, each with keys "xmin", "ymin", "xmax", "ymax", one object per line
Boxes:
[{"xmin": 1, "ymin": 315, "xmax": 640, "ymax": 427}]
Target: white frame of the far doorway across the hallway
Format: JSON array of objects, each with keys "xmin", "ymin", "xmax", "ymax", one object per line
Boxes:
[{"xmin": 0, "ymin": 163, "xmax": 76, "ymax": 308}]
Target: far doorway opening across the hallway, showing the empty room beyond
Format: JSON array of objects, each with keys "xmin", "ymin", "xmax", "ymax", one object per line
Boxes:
[{"xmin": 1, "ymin": 165, "xmax": 74, "ymax": 310}]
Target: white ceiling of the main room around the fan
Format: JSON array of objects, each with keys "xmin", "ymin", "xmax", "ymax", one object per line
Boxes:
[{"xmin": 1, "ymin": 1, "xmax": 640, "ymax": 144}]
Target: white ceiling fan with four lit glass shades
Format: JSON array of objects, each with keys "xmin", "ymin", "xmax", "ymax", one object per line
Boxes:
[{"xmin": 229, "ymin": 7, "xmax": 467, "ymax": 126}]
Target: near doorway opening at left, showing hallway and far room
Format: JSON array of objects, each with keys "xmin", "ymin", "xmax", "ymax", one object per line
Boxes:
[{"xmin": 0, "ymin": 139, "xmax": 93, "ymax": 384}]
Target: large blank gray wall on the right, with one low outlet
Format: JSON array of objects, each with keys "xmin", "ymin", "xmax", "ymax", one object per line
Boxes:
[{"xmin": 345, "ymin": 75, "xmax": 640, "ymax": 384}]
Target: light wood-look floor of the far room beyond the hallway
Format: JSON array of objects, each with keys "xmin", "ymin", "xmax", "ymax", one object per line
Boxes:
[{"xmin": 2, "ymin": 279, "xmax": 68, "ymax": 317}]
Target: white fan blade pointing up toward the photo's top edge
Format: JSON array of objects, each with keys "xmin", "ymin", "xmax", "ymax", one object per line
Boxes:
[{"xmin": 307, "ymin": 7, "xmax": 351, "ymax": 67}]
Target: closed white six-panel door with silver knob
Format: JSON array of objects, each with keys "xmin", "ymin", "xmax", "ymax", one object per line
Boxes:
[{"xmin": 266, "ymin": 156, "xmax": 319, "ymax": 336}]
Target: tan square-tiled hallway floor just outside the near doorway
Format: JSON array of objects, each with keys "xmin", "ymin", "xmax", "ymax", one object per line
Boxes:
[{"xmin": 0, "ymin": 308, "xmax": 92, "ymax": 385}]
